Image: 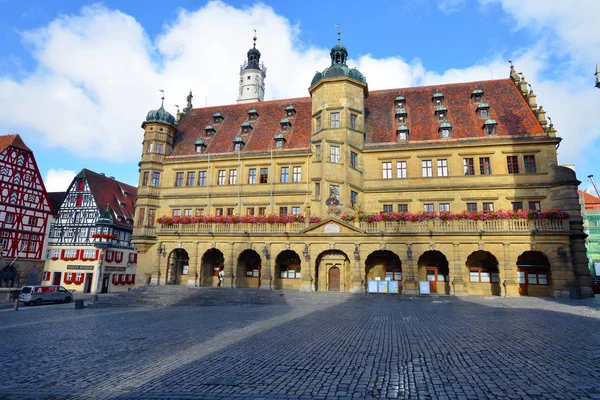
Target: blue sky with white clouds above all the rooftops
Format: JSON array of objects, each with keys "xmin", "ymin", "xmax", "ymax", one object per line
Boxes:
[{"xmin": 0, "ymin": 0, "xmax": 600, "ymax": 190}]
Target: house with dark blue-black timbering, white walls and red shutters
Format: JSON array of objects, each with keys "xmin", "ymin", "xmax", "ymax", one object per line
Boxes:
[{"xmin": 43, "ymin": 169, "xmax": 137, "ymax": 293}]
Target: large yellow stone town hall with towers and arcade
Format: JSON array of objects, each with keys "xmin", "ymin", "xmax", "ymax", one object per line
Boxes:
[{"xmin": 132, "ymin": 41, "xmax": 590, "ymax": 296}]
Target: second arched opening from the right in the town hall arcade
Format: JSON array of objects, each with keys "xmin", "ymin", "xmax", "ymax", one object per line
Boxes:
[{"xmin": 466, "ymin": 250, "xmax": 501, "ymax": 296}]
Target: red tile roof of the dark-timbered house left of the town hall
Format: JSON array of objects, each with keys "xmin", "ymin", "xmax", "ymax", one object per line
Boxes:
[{"xmin": 78, "ymin": 169, "xmax": 137, "ymax": 228}]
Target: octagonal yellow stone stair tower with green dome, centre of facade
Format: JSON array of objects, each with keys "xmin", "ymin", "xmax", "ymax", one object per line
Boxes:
[{"xmin": 308, "ymin": 33, "xmax": 369, "ymax": 216}]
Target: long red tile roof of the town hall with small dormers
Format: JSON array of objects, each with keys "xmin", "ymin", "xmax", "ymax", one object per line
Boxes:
[{"xmin": 171, "ymin": 79, "xmax": 546, "ymax": 156}]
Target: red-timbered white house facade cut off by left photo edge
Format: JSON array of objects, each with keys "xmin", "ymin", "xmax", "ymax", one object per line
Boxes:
[{"xmin": 0, "ymin": 135, "xmax": 53, "ymax": 286}]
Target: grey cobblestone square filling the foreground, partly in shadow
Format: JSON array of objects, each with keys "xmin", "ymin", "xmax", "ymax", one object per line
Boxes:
[{"xmin": 0, "ymin": 295, "xmax": 600, "ymax": 400}]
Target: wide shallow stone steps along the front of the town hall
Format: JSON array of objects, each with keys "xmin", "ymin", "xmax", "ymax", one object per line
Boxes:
[{"xmin": 87, "ymin": 285, "xmax": 407, "ymax": 308}]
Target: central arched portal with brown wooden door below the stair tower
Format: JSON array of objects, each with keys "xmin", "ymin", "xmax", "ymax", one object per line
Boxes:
[{"xmin": 315, "ymin": 250, "xmax": 351, "ymax": 292}]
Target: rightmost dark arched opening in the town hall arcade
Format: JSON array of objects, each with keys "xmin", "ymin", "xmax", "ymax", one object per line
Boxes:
[{"xmin": 517, "ymin": 251, "xmax": 552, "ymax": 296}]
